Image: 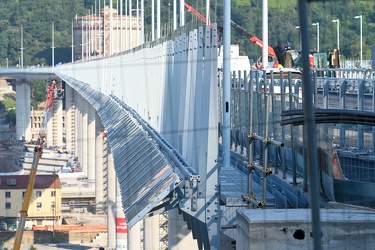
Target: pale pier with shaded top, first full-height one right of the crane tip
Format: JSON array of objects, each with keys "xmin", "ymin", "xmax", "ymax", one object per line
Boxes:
[{"xmin": 65, "ymin": 84, "xmax": 76, "ymax": 153}]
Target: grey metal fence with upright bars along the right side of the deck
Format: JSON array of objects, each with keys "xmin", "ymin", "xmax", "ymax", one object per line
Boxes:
[{"xmin": 223, "ymin": 69, "xmax": 375, "ymax": 187}]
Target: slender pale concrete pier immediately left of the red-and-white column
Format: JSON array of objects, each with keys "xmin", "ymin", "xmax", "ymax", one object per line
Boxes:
[{"xmin": 107, "ymin": 147, "xmax": 117, "ymax": 249}]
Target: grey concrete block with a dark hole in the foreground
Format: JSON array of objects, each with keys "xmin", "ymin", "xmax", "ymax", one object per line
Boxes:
[{"xmin": 236, "ymin": 209, "xmax": 375, "ymax": 250}]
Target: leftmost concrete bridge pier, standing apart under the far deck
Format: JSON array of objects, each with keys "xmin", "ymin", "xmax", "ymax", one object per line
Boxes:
[{"xmin": 14, "ymin": 80, "xmax": 31, "ymax": 141}]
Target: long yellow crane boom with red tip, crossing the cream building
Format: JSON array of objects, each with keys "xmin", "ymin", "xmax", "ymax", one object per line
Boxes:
[{"xmin": 13, "ymin": 81, "xmax": 55, "ymax": 250}]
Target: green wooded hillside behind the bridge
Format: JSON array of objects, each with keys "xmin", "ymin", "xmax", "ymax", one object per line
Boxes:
[{"xmin": 0, "ymin": 0, "xmax": 375, "ymax": 66}]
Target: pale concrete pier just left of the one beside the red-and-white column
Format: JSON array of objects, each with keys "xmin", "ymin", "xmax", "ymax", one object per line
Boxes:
[{"xmin": 95, "ymin": 113, "xmax": 105, "ymax": 213}]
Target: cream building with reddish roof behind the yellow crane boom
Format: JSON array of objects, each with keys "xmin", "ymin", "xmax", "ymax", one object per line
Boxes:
[{"xmin": 0, "ymin": 175, "xmax": 61, "ymax": 230}]
